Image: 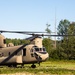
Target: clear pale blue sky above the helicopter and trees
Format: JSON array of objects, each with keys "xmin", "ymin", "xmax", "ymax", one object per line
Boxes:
[{"xmin": 0, "ymin": 0, "xmax": 75, "ymax": 38}]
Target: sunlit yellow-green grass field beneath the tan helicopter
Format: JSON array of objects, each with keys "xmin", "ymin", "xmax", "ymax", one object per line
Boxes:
[{"xmin": 0, "ymin": 60, "xmax": 75, "ymax": 75}]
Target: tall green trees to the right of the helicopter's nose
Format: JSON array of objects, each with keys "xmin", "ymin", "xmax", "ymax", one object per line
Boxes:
[{"xmin": 45, "ymin": 19, "xmax": 75, "ymax": 60}]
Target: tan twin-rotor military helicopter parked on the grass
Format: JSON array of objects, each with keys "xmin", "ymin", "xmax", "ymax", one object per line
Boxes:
[{"xmin": 0, "ymin": 30, "xmax": 49, "ymax": 68}]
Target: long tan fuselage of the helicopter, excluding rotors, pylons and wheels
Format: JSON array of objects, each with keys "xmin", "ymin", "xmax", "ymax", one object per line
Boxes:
[{"xmin": 0, "ymin": 44, "xmax": 48, "ymax": 65}]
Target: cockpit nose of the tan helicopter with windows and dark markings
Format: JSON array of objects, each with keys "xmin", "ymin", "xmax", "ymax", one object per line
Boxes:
[{"xmin": 31, "ymin": 46, "xmax": 49, "ymax": 63}]
